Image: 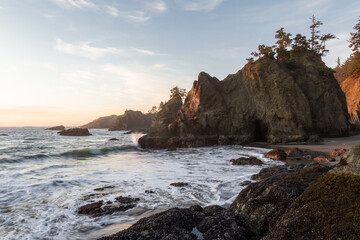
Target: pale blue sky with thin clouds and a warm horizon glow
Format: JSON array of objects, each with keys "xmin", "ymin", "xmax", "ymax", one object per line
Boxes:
[{"xmin": 0, "ymin": 0, "xmax": 360, "ymax": 127}]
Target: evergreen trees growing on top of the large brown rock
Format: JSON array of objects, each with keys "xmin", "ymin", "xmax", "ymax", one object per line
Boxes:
[{"xmin": 247, "ymin": 15, "xmax": 336, "ymax": 60}]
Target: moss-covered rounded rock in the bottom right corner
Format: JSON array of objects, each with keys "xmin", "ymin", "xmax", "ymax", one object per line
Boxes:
[{"xmin": 265, "ymin": 173, "xmax": 360, "ymax": 240}]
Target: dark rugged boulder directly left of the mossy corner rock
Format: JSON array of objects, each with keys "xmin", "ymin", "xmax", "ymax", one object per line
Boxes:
[{"xmin": 229, "ymin": 165, "xmax": 330, "ymax": 239}]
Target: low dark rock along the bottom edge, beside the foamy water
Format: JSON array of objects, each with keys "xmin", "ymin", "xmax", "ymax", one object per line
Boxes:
[{"xmin": 101, "ymin": 206, "xmax": 253, "ymax": 240}]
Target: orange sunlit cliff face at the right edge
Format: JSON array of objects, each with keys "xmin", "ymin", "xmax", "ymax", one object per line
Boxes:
[{"xmin": 341, "ymin": 73, "xmax": 360, "ymax": 123}]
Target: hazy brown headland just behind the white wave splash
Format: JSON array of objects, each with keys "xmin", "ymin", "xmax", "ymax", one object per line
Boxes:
[{"xmin": 109, "ymin": 110, "xmax": 153, "ymax": 131}]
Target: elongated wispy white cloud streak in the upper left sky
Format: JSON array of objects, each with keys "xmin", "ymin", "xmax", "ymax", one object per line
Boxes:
[{"xmin": 55, "ymin": 38, "xmax": 124, "ymax": 59}]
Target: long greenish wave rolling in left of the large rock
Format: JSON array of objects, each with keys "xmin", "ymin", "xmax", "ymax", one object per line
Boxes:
[{"xmin": 0, "ymin": 144, "xmax": 140, "ymax": 163}]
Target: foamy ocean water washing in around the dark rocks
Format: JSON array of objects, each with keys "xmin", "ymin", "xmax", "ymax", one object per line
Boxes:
[{"xmin": 0, "ymin": 128, "xmax": 282, "ymax": 239}]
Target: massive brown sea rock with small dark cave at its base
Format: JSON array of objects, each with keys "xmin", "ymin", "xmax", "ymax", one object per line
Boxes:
[{"xmin": 139, "ymin": 52, "xmax": 349, "ymax": 148}]
